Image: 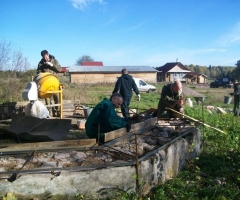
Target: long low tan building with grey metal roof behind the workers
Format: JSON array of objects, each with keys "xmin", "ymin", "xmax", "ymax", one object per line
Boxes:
[{"xmin": 68, "ymin": 65, "xmax": 158, "ymax": 83}]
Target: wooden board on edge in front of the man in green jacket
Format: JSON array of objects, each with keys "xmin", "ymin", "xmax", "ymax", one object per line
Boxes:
[{"xmin": 104, "ymin": 117, "xmax": 157, "ymax": 142}]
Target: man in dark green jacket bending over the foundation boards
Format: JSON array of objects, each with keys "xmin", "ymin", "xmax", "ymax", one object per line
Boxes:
[{"xmin": 85, "ymin": 93, "xmax": 131, "ymax": 143}]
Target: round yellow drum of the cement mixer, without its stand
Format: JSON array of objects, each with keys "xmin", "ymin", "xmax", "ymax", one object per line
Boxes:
[{"xmin": 34, "ymin": 72, "xmax": 60, "ymax": 99}]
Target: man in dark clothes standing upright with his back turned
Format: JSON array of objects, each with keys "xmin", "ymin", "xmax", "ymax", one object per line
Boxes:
[{"xmin": 112, "ymin": 68, "xmax": 141, "ymax": 118}]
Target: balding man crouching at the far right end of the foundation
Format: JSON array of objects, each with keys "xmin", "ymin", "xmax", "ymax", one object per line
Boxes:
[{"xmin": 157, "ymin": 80, "xmax": 183, "ymax": 118}]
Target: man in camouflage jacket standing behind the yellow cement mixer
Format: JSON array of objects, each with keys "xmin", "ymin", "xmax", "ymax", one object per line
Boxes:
[{"xmin": 37, "ymin": 50, "xmax": 62, "ymax": 117}]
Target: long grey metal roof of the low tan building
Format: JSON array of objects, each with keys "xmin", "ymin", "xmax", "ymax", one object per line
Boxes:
[{"xmin": 69, "ymin": 66, "xmax": 158, "ymax": 73}]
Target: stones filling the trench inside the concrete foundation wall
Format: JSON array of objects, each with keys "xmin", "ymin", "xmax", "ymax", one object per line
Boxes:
[{"xmin": 0, "ymin": 121, "xmax": 190, "ymax": 172}]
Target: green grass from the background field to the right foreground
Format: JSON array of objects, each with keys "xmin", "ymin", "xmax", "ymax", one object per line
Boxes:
[{"xmin": 64, "ymin": 80, "xmax": 240, "ymax": 200}]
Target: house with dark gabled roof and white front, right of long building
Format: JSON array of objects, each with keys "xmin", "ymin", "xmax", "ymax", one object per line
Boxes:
[{"xmin": 156, "ymin": 62, "xmax": 191, "ymax": 82}]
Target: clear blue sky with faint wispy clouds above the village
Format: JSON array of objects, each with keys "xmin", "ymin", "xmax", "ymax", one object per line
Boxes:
[{"xmin": 0, "ymin": 0, "xmax": 240, "ymax": 68}]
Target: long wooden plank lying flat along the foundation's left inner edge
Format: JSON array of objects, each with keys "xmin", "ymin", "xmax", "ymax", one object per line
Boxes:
[{"xmin": 0, "ymin": 139, "xmax": 96, "ymax": 154}]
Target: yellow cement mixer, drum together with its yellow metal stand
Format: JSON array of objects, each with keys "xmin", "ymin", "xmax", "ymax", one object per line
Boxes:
[{"xmin": 34, "ymin": 72, "xmax": 63, "ymax": 119}]
